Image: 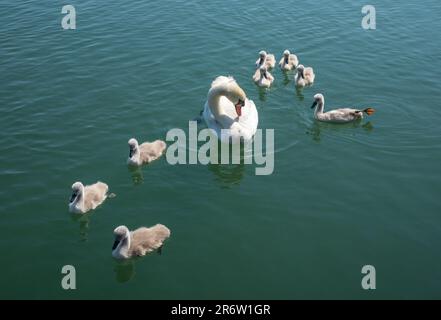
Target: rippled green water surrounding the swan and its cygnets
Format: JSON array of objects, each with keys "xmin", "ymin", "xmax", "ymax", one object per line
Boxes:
[{"xmin": 0, "ymin": 0, "xmax": 441, "ymax": 299}]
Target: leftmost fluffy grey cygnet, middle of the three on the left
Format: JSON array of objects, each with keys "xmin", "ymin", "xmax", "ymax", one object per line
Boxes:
[{"xmin": 69, "ymin": 181, "xmax": 109, "ymax": 213}]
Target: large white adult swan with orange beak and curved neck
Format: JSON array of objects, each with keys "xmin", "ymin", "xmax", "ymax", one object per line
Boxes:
[{"xmin": 203, "ymin": 76, "xmax": 259, "ymax": 143}]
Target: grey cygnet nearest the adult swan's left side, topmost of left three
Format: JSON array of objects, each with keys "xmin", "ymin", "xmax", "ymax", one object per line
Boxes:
[{"xmin": 127, "ymin": 138, "xmax": 167, "ymax": 166}]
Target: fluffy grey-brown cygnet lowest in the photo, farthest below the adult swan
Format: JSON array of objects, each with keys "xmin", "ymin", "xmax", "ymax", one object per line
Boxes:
[{"xmin": 112, "ymin": 224, "xmax": 170, "ymax": 259}]
